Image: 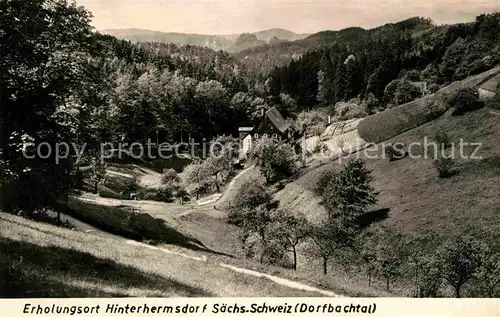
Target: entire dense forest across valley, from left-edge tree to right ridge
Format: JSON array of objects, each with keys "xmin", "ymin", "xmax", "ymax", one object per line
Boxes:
[{"xmin": 0, "ymin": 0, "xmax": 500, "ymax": 235}]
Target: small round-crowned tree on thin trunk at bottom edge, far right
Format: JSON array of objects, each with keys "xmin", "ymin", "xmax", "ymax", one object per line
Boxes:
[{"xmin": 439, "ymin": 236, "xmax": 484, "ymax": 298}]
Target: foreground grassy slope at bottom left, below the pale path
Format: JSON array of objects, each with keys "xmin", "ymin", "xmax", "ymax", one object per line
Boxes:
[{"xmin": 0, "ymin": 212, "xmax": 312, "ymax": 297}]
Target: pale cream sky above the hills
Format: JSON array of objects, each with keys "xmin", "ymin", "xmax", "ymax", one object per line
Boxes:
[{"xmin": 76, "ymin": 0, "xmax": 500, "ymax": 34}]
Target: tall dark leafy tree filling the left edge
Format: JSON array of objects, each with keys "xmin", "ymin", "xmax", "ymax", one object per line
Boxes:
[{"xmin": 0, "ymin": 0, "xmax": 95, "ymax": 214}]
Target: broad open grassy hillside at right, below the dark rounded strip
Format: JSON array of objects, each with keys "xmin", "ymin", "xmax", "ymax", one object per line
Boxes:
[{"xmin": 367, "ymin": 108, "xmax": 500, "ymax": 243}]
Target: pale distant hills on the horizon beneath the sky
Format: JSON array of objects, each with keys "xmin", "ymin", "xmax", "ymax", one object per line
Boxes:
[{"xmin": 101, "ymin": 29, "xmax": 309, "ymax": 52}]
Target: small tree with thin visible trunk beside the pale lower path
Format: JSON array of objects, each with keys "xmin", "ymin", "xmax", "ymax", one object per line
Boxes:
[{"xmin": 272, "ymin": 210, "xmax": 311, "ymax": 270}]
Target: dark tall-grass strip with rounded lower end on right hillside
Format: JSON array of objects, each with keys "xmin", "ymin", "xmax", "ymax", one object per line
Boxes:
[{"xmin": 358, "ymin": 67, "xmax": 500, "ymax": 143}]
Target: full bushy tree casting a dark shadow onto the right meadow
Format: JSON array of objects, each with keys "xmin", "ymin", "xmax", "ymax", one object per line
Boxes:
[{"xmin": 319, "ymin": 159, "xmax": 377, "ymax": 220}]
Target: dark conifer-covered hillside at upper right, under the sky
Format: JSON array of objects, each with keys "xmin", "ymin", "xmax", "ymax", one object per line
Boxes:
[{"xmin": 269, "ymin": 14, "xmax": 500, "ymax": 113}]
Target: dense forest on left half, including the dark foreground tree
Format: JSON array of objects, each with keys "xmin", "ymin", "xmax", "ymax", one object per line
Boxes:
[{"xmin": 0, "ymin": 0, "xmax": 293, "ymax": 212}]
